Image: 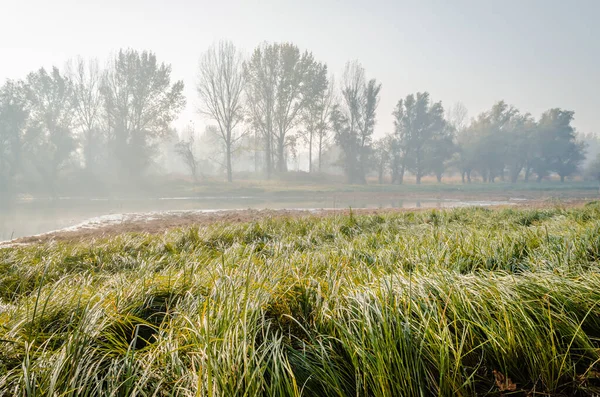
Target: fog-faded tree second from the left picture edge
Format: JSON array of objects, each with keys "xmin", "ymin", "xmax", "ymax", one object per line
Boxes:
[{"xmin": 25, "ymin": 67, "xmax": 77, "ymax": 195}]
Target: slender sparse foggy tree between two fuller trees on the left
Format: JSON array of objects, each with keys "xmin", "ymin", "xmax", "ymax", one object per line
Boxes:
[{"xmin": 66, "ymin": 58, "xmax": 105, "ymax": 172}]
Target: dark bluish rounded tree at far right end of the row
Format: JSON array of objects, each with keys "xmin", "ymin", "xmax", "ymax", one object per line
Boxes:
[{"xmin": 534, "ymin": 108, "xmax": 585, "ymax": 182}]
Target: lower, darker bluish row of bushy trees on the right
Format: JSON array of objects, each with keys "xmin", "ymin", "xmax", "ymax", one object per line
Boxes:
[{"xmin": 373, "ymin": 99, "xmax": 585, "ymax": 184}]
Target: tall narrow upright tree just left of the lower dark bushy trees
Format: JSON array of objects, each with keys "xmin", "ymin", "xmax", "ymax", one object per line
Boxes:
[{"xmin": 331, "ymin": 61, "xmax": 381, "ymax": 184}]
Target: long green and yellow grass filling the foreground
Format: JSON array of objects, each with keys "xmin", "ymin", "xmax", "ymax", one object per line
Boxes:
[{"xmin": 0, "ymin": 203, "xmax": 600, "ymax": 397}]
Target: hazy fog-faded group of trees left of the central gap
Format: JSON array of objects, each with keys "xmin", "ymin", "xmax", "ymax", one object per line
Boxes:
[{"xmin": 0, "ymin": 50, "xmax": 186, "ymax": 195}]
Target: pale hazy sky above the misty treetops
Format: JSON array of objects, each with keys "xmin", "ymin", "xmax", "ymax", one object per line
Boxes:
[{"xmin": 0, "ymin": 0, "xmax": 600, "ymax": 136}]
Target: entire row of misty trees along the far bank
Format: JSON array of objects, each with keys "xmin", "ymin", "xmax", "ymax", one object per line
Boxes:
[{"xmin": 0, "ymin": 42, "xmax": 585, "ymax": 198}]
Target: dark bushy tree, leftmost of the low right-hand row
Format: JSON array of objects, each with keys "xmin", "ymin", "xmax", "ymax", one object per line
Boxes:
[{"xmin": 394, "ymin": 92, "xmax": 452, "ymax": 184}]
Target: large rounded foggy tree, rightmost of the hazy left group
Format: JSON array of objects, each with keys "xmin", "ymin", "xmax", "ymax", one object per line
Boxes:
[{"xmin": 101, "ymin": 50, "xmax": 185, "ymax": 176}]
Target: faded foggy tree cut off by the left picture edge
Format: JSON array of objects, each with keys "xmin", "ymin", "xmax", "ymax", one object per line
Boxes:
[{"xmin": 0, "ymin": 80, "xmax": 29, "ymax": 199}]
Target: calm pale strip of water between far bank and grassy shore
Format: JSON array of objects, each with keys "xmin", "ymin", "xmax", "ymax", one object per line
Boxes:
[{"xmin": 0, "ymin": 196, "xmax": 506, "ymax": 241}]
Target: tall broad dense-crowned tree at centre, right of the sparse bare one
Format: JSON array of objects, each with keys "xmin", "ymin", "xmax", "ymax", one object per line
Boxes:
[{"xmin": 244, "ymin": 43, "xmax": 323, "ymax": 177}]
